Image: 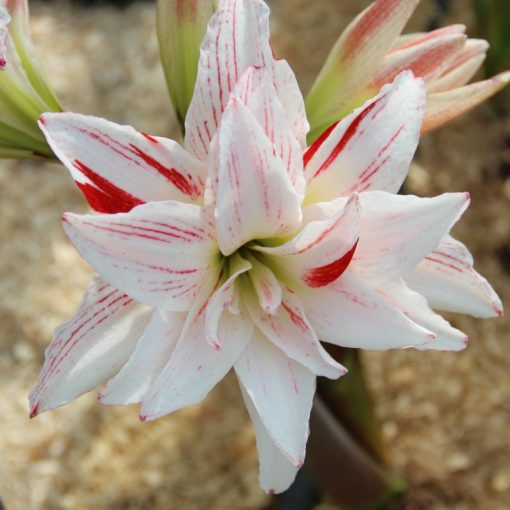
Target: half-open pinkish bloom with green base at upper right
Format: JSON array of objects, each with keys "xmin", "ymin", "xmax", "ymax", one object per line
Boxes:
[{"xmin": 306, "ymin": 0, "xmax": 510, "ymax": 140}]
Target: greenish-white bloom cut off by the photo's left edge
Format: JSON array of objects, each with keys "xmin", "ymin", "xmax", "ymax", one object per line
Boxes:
[{"xmin": 0, "ymin": 0, "xmax": 61, "ymax": 158}]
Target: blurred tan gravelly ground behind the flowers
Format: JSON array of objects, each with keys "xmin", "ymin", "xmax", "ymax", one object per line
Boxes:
[{"xmin": 0, "ymin": 0, "xmax": 510, "ymax": 510}]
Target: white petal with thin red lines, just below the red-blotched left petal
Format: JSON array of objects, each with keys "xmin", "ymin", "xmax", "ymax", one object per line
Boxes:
[{"xmin": 63, "ymin": 201, "xmax": 220, "ymax": 311}]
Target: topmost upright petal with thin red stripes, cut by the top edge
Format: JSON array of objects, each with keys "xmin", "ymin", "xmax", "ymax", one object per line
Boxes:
[{"xmin": 185, "ymin": 0, "xmax": 272, "ymax": 160}]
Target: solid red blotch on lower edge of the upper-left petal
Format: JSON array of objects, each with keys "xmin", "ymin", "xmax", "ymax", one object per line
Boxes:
[{"xmin": 73, "ymin": 160, "xmax": 145, "ymax": 214}]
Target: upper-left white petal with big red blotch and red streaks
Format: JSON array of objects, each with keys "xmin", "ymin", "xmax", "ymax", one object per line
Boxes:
[{"xmin": 39, "ymin": 113, "xmax": 207, "ymax": 213}]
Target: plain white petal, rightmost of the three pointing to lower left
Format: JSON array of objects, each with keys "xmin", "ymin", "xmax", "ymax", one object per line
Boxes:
[{"xmin": 140, "ymin": 282, "xmax": 253, "ymax": 420}]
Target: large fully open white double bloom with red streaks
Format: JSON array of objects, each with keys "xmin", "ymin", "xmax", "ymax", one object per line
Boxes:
[{"xmin": 30, "ymin": 0, "xmax": 501, "ymax": 492}]
